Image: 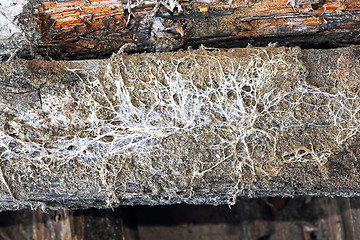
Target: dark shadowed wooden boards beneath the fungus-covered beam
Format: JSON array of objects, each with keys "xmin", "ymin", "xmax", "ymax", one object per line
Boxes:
[{"xmin": 0, "ymin": 197, "xmax": 360, "ymax": 240}]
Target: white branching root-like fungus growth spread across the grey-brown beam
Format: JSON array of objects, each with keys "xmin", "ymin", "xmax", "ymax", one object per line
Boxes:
[{"xmin": 0, "ymin": 48, "xmax": 360, "ymax": 206}]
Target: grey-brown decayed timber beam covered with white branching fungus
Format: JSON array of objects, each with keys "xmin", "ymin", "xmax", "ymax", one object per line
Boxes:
[{"xmin": 0, "ymin": 47, "xmax": 360, "ymax": 209}]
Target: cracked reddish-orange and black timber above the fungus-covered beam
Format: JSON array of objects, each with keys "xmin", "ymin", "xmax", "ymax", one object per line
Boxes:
[{"xmin": 0, "ymin": 0, "xmax": 360, "ymax": 59}]
